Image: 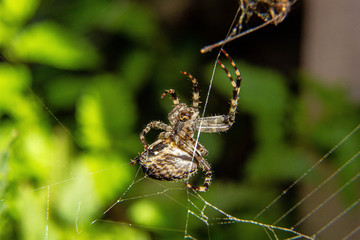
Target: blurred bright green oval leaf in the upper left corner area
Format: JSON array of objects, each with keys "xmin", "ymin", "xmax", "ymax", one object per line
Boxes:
[{"xmin": 10, "ymin": 22, "xmax": 99, "ymax": 69}]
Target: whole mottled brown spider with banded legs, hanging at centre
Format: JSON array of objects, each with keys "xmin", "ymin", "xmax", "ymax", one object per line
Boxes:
[{"xmin": 130, "ymin": 49, "xmax": 241, "ymax": 192}]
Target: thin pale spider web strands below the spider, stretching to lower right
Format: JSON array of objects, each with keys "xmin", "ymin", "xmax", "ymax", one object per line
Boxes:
[{"xmin": 63, "ymin": 124, "xmax": 360, "ymax": 239}]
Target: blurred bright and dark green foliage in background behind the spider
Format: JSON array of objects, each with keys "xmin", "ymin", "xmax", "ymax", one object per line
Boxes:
[{"xmin": 0, "ymin": 0, "xmax": 359, "ymax": 239}]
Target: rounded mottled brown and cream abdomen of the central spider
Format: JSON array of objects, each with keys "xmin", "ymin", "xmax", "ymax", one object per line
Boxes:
[{"xmin": 138, "ymin": 140, "xmax": 198, "ymax": 181}]
